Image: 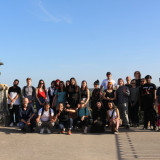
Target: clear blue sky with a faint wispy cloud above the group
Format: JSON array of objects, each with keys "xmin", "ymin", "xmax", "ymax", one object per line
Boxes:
[{"xmin": 0, "ymin": 0, "xmax": 160, "ymax": 87}]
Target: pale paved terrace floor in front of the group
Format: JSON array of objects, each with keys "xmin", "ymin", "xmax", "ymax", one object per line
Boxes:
[{"xmin": 0, "ymin": 127, "xmax": 160, "ymax": 160}]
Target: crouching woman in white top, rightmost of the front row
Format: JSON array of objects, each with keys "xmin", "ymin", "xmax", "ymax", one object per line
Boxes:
[{"xmin": 107, "ymin": 102, "xmax": 120, "ymax": 134}]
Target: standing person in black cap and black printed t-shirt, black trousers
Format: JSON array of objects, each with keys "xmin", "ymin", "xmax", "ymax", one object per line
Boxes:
[{"xmin": 142, "ymin": 75, "xmax": 156, "ymax": 130}]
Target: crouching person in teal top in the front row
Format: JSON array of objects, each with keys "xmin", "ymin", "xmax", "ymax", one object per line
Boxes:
[{"xmin": 74, "ymin": 100, "xmax": 89, "ymax": 134}]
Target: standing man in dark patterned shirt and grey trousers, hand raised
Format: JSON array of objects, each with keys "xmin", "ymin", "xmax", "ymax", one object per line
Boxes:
[{"xmin": 116, "ymin": 78, "xmax": 130, "ymax": 129}]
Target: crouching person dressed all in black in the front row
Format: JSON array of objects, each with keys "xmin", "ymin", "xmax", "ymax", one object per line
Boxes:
[{"xmin": 91, "ymin": 102, "xmax": 106, "ymax": 133}]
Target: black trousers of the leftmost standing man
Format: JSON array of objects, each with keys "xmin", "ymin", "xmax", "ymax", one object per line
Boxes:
[{"xmin": 8, "ymin": 104, "xmax": 19, "ymax": 123}]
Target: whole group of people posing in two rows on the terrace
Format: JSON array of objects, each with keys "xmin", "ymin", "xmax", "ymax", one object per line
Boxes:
[{"xmin": 8, "ymin": 71, "xmax": 160, "ymax": 135}]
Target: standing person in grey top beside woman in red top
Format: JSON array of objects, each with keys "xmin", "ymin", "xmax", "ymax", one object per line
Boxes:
[{"xmin": 22, "ymin": 78, "xmax": 36, "ymax": 107}]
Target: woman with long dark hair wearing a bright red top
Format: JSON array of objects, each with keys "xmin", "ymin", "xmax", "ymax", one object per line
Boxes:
[{"xmin": 36, "ymin": 79, "xmax": 47, "ymax": 112}]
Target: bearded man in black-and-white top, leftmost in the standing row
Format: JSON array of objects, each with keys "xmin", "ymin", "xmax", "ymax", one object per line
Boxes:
[{"xmin": 8, "ymin": 79, "xmax": 21, "ymax": 127}]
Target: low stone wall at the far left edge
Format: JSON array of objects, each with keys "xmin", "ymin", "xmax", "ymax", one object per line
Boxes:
[{"xmin": 0, "ymin": 84, "xmax": 9, "ymax": 125}]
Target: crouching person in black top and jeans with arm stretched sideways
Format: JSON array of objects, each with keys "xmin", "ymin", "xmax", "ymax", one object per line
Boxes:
[{"xmin": 56, "ymin": 103, "xmax": 73, "ymax": 135}]
